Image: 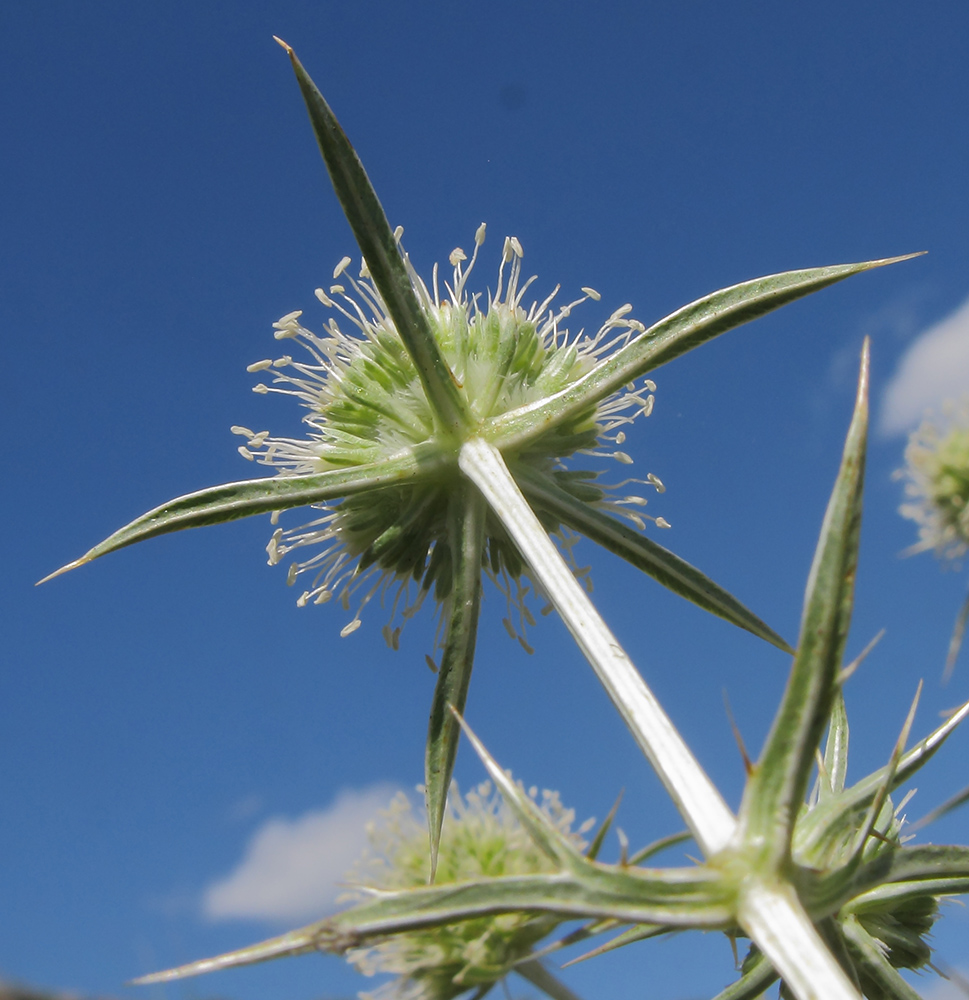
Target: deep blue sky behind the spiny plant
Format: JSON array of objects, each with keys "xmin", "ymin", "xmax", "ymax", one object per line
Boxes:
[{"xmin": 0, "ymin": 0, "xmax": 969, "ymax": 1000}]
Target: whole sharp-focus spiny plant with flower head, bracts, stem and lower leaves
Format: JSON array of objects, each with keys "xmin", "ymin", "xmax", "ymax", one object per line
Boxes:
[{"xmin": 39, "ymin": 37, "xmax": 969, "ymax": 1000}]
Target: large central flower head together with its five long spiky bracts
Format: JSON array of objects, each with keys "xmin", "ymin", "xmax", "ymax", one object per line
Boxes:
[{"xmin": 41, "ymin": 44, "xmax": 908, "ymax": 863}]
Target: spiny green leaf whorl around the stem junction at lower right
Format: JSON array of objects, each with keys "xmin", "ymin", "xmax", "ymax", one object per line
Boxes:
[{"xmin": 129, "ymin": 343, "xmax": 969, "ymax": 1000}]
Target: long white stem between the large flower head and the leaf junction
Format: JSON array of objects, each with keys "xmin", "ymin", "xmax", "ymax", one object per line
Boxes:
[{"xmin": 459, "ymin": 438, "xmax": 737, "ymax": 856}]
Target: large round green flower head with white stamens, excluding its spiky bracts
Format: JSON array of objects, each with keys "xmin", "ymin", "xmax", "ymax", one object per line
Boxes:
[{"xmin": 233, "ymin": 224, "xmax": 668, "ymax": 648}]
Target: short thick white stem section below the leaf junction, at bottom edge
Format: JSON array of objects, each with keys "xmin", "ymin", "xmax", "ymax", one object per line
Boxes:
[{"xmin": 738, "ymin": 881, "xmax": 862, "ymax": 1000}]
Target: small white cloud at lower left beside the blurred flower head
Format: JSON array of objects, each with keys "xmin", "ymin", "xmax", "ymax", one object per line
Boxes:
[{"xmin": 202, "ymin": 785, "xmax": 397, "ymax": 922}]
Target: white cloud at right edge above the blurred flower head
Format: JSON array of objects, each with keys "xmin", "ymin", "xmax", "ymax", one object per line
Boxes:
[{"xmin": 880, "ymin": 290, "xmax": 969, "ymax": 435}]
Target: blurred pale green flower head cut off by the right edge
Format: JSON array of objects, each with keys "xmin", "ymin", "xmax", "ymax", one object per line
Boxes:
[{"xmin": 899, "ymin": 397, "xmax": 969, "ymax": 559}]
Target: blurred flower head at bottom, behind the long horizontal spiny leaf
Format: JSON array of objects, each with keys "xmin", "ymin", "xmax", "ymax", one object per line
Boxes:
[{"xmin": 347, "ymin": 782, "xmax": 593, "ymax": 1000}]
